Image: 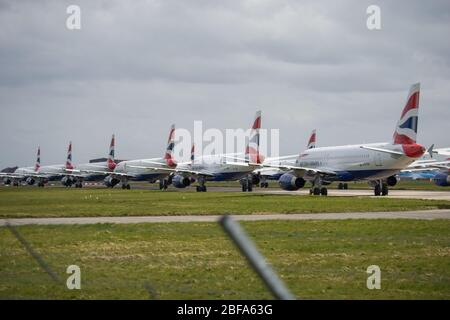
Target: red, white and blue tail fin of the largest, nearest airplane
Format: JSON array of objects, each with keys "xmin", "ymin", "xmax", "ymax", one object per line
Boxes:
[{"xmin": 393, "ymin": 83, "xmax": 420, "ymax": 144}]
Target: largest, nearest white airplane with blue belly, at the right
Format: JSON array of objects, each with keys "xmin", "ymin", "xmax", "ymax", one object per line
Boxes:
[{"xmin": 265, "ymin": 83, "xmax": 425, "ymax": 196}]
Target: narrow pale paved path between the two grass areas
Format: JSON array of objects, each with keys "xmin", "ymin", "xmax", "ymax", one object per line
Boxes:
[{"xmin": 0, "ymin": 210, "xmax": 450, "ymax": 226}]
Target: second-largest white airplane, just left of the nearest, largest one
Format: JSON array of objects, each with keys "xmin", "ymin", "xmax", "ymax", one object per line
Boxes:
[{"xmin": 172, "ymin": 111, "xmax": 264, "ymax": 192}]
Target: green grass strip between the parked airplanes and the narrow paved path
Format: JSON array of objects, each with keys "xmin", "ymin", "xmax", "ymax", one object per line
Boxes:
[{"xmin": 0, "ymin": 188, "xmax": 450, "ymax": 217}]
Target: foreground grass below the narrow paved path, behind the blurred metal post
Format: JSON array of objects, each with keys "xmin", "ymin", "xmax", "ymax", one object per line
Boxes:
[{"xmin": 0, "ymin": 220, "xmax": 450, "ymax": 299}]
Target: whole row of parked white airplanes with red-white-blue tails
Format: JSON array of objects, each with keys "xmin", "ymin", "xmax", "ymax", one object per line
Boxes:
[{"xmin": 1, "ymin": 83, "xmax": 450, "ymax": 196}]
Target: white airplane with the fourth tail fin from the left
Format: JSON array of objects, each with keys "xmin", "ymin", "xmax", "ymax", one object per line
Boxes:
[{"xmin": 105, "ymin": 125, "xmax": 177, "ymax": 189}]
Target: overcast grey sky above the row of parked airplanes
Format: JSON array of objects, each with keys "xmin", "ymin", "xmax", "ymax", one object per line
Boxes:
[{"xmin": 0, "ymin": 0, "xmax": 450, "ymax": 168}]
